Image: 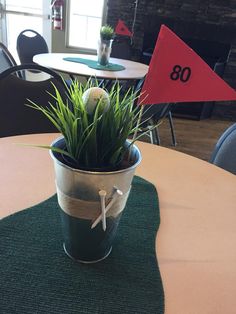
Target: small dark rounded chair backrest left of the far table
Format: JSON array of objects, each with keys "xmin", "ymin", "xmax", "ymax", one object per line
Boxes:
[{"xmin": 16, "ymin": 29, "xmax": 48, "ymax": 64}]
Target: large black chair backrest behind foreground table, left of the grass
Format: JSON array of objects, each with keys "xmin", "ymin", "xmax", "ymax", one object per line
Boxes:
[{"xmin": 0, "ymin": 64, "xmax": 66, "ymax": 137}]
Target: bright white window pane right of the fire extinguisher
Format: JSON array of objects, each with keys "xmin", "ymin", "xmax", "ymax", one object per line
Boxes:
[{"xmin": 67, "ymin": 0, "xmax": 106, "ymax": 50}]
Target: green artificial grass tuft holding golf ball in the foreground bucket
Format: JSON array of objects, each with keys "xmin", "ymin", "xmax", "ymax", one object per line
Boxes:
[{"xmin": 28, "ymin": 80, "xmax": 153, "ymax": 169}]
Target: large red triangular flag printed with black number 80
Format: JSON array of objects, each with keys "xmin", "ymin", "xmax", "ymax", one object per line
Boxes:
[{"xmin": 139, "ymin": 25, "xmax": 236, "ymax": 105}]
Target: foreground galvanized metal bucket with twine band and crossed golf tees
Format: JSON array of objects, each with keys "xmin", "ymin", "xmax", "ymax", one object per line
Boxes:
[{"xmin": 50, "ymin": 137, "xmax": 141, "ymax": 263}]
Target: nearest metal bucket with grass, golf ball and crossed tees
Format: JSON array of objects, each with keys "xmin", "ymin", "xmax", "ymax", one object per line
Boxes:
[{"xmin": 29, "ymin": 80, "xmax": 153, "ymax": 262}]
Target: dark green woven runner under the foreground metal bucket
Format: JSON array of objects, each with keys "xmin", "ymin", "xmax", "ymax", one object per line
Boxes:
[{"xmin": 0, "ymin": 177, "xmax": 164, "ymax": 314}]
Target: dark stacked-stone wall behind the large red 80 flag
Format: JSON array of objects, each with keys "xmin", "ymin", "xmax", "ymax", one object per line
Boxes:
[{"xmin": 107, "ymin": 0, "xmax": 236, "ymax": 121}]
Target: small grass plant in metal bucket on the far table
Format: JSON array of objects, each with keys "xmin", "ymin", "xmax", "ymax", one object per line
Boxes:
[{"xmin": 97, "ymin": 25, "xmax": 114, "ymax": 66}]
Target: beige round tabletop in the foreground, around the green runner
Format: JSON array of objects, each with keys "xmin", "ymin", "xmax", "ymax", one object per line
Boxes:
[{"xmin": 0, "ymin": 134, "xmax": 236, "ymax": 314}]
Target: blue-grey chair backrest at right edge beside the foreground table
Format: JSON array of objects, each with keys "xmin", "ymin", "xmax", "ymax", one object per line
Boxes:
[{"xmin": 210, "ymin": 123, "xmax": 236, "ymax": 174}]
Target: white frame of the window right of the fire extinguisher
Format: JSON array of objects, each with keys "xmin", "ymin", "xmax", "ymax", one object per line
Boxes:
[{"xmin": 65, "ymin": 0, "xmax": 108, "ymax": 54}]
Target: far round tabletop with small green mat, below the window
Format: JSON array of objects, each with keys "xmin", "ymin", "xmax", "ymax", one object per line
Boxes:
[{"xmin": 33, "ymin": 53, "xmax": 148, "ymax": 80}]
